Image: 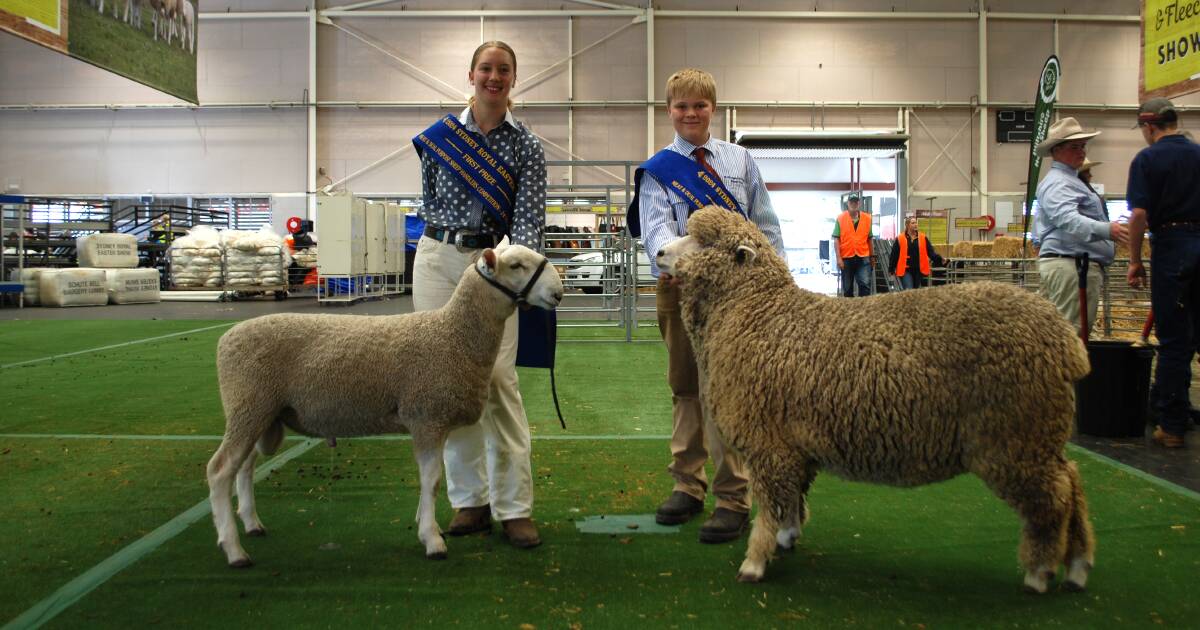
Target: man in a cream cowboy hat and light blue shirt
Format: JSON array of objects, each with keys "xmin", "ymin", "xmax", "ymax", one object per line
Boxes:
[{"xmin": 1033, "ymin": 118, "xmax": 1128, "ymax": 330}]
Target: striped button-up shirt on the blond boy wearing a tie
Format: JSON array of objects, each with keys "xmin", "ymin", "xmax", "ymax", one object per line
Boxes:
[{"xmin": 637, "ymin": 133, "xmax": 784, "ymax": 277}]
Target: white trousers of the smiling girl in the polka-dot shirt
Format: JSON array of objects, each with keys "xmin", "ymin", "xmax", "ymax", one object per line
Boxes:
[{"xmin": 413, "ymin": 236, "xmax": 533, "ymax": 521}]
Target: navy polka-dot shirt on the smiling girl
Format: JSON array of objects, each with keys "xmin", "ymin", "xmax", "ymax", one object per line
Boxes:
[{"xmin": 416, "ymin": 107, "xmax": 546, "ymax": 252}]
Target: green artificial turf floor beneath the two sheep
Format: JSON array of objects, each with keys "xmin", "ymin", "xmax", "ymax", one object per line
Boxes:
[{"xmin": 0, "ymin": 322, "xmax": 1200, "ymax": 628}]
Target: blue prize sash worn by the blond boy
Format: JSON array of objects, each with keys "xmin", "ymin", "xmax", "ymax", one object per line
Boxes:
[{"xmin": 625, "ymin": 149, "xmax": 746, "ymax": 236}]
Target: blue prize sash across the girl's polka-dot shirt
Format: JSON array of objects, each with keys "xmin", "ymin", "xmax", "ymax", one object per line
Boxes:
[{"xmin": 413, "ymin": 114, "xmax": 517, "ymax": 233}]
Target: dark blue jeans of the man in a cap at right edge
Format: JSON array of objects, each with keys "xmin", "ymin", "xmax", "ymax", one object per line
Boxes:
[{"xmin": 1150, "ymin": 229, "xmax": 1200, "ymax": 436}]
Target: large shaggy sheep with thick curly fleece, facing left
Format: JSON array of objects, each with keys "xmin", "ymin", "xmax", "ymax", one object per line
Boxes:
[{"xmin": 658, "ymin": 208, "xmax": 1094, "ymax": 593}]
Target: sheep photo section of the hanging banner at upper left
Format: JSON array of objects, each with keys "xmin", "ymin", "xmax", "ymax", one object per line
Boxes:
[{"xmin": 67, "ymin": 0, "xmax": 199, "ymax": 104}]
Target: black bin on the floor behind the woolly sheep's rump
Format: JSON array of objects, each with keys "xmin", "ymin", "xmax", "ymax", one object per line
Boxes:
[{"xmin": 1075, "ymin": 341, "xmax": 1154, "ymax": 438}]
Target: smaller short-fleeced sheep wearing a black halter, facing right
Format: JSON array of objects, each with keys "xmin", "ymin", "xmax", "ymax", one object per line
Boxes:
[{"xmin": 208, "ymin": 245, "xmax": 563, "ymax": 566}]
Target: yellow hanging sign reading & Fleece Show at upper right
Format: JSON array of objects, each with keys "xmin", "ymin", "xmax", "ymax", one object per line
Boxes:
[{"xmin": 1139, "ymin": 0, "xmax": 1200, "ymax": 101}]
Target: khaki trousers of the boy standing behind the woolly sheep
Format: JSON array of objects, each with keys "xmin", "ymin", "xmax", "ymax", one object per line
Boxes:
[{"xmin": 656, "ymin": 280, "xmax": 750, "ymax": 512}]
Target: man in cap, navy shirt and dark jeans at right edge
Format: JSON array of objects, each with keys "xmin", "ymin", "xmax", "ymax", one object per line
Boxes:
[{"xmin": 1126, "ymin": 98, "xmax": 1200, "ymax": 449}]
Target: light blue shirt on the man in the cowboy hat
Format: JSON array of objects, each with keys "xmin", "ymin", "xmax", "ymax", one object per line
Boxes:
[{"xmin": 1032, "ymin": 162, "xmax": 1116, "ymax": 265}]
